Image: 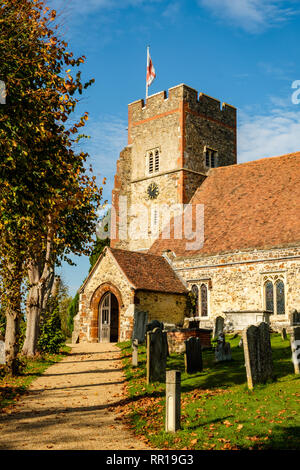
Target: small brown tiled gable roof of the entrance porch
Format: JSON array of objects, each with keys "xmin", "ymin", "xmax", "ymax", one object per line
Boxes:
[{"xmin": 108, "ymin": 247, "xmax": 187, "ymax": 294}]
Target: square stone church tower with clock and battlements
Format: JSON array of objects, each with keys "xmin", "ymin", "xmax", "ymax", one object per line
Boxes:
[{"xmin": 111, "ymin": 84, "xmax": 237, "ymax": 251}]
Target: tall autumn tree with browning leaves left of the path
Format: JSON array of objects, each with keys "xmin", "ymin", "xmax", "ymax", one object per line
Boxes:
[{"xmin": 0, "ymin": 0, "xmax": 102, "ymax": 371}]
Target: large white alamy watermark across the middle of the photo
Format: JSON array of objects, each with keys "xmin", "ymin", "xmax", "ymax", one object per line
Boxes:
[{"xmin": 96, "ymin": 196, "xmax": 204, "ymax": 251}]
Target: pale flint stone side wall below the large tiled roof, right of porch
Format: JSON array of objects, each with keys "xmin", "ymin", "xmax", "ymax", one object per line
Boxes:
[{"xmin": 173, "ymin": 247, "xmax": 300, "ymax": 331}]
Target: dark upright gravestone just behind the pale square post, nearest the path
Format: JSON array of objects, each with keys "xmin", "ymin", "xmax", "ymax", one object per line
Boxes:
[{"xmin": 147, "ymin": 328, "xmax": 168, "ymax": 384}]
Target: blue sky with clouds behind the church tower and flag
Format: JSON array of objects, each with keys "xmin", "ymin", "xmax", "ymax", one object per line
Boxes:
[{"xmin": 49, "ymin": 0, "xmax": 300, "ymax": 295}]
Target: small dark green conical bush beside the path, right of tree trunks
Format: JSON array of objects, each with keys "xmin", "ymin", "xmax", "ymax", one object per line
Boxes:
[{"xmin": 38, "ymin": 306, "xmax": 65, "ymax": 354}]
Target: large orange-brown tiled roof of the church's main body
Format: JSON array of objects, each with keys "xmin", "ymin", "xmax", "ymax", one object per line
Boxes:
[{"xmin": 150, "ymin": 152, "xmax": 300, "ymax": 257}]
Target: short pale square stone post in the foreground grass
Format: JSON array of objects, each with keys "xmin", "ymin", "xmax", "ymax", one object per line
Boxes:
[{"xmin": 165, "ymin": 370, "xmax": 181, "ymax": 432}]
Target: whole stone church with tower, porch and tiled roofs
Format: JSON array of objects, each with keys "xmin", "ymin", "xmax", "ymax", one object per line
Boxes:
[{"xmin": 74, "ymin": 84, "xmax": 300, "ymax": 342}]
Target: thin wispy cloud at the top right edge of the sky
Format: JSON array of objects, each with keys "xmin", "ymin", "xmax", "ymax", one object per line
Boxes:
[{"xmin": 198, "ymin": 0, "xmax": 299, "ymax": 32}]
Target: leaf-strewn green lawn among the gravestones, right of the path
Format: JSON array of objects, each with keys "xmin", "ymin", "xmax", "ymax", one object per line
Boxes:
[{"xmin": 118, "ymin": 334, "xmax": 300, "ymax": 450}]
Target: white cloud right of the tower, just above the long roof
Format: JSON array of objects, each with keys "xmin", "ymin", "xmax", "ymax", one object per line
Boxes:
[{"xmin": 238, "ymin": 103, "xmax": 300, "ymax": 163}]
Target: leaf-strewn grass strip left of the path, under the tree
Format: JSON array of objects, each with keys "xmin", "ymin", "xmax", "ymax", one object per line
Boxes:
[{"xmin": 0, "ymin": 346, "xmax": 70, "ymax": 411}]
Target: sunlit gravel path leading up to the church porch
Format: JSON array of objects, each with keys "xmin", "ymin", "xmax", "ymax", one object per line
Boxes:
[{"xmin": 0, "ymin": 343, "xmax": 149, "ymax": 450}]
